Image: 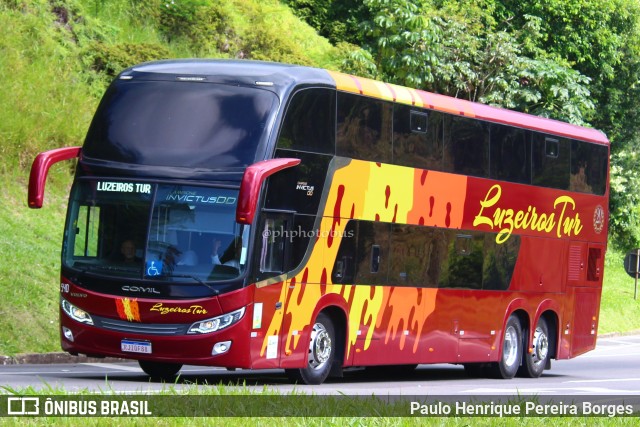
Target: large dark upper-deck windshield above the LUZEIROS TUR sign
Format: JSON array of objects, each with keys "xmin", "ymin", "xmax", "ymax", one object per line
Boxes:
[{"xmin": 82, "ymin": 80, "xmax": 277, "ymax": 169}]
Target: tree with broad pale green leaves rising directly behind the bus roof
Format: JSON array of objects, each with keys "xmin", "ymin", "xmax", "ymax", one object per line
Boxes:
[{"xmin": 344, "ymin": 0, "xmax": 594, "ymax": 124}]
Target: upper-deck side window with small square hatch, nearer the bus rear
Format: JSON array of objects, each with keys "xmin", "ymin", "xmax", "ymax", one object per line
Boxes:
[{"xmin": 531, "ymin": 133, "xmax": 571, "ymax": 190}]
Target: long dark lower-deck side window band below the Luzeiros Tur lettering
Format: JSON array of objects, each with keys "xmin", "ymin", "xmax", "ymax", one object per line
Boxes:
[{"xmin": 331, "ymin": 220, "xmax": 520, "ymax": 290}]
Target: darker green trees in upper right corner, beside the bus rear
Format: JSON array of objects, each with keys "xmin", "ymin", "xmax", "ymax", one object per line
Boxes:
[{"xmin": 496, "ymin": 0, "xmax": 640, "ymax": 247}]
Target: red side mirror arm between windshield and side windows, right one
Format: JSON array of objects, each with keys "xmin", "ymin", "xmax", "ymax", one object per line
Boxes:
[{"xmin": 236, "ymin": 158, "xmax": 301, "ymax": 224}]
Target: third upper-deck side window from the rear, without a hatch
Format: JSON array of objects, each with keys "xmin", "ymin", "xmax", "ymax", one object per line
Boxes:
[{"xmin": 490, "ymin": 125, "xmax": 531, "ymax": 184}]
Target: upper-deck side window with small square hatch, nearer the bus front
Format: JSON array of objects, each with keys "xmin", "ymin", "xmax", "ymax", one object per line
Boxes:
[{"xmin": 393, "ymin": 104, "xmax": 442, "ymax": 170}]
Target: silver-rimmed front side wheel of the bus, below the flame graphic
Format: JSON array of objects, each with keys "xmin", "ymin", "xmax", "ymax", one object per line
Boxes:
[{"xmin": 286, "ymin": 313, "xmax": 336, "ymax": 385}]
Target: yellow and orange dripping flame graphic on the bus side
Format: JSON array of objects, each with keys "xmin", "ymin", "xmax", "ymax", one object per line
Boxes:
[{"xmin": 261, "ymin": 160, "xmax": 467, "ymax": 360}]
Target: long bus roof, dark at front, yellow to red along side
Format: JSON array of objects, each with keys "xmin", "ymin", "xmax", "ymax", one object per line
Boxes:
[{"xmin": 120, "ymin": 59, "xmax": 609, "ymax": 145}]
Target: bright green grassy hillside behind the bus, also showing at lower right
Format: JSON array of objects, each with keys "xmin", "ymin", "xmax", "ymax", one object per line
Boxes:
[{"xmin": 0, "ymin": 0, "xmax": 640, "ymax": 355}]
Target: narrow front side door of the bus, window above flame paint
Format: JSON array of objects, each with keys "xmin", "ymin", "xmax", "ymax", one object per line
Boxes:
[{"xmin": 251, "ymin": 211, "xmax": 294, "ymax": 368}]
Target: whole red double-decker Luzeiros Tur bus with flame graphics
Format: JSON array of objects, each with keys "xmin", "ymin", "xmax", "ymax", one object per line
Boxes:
[{"xmin": 29, "ymin": 60, "xmax": 609, "ymax": 384}]
